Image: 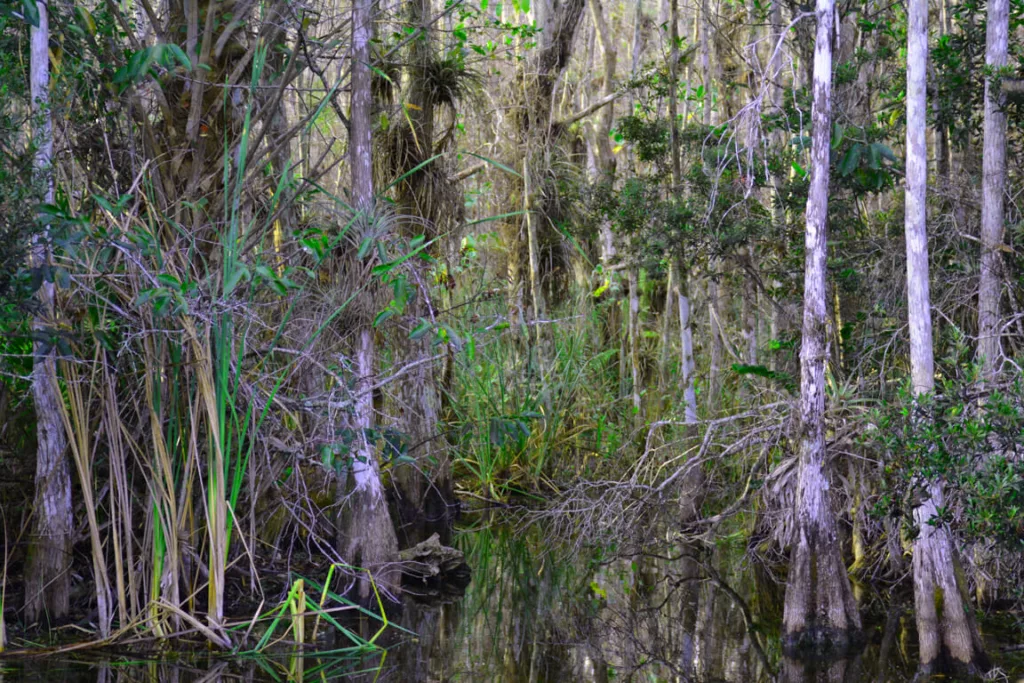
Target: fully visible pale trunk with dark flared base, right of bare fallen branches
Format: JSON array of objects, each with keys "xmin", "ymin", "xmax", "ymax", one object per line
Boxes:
[{"xmin": 782, "ymin": 0, "xmax": 860, "ymax": 650}]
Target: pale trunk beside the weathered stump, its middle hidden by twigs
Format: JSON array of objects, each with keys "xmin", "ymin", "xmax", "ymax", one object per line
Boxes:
[{"xmin": 338, "ymin": 0, "xmax": 400, "ymax": 598}]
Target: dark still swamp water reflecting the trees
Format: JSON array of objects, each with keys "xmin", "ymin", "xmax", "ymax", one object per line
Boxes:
[{"xmin": 0, "ymin": 514, "xmax": 1024, "ymax": 683}]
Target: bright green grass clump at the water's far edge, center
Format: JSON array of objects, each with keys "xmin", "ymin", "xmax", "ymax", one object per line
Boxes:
[{"xmin": 450, "ymin": 296, "xmax": 631, "ymax": 498}]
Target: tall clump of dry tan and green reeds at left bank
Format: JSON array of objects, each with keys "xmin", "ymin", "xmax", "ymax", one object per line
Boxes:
[{"xmin": 17, "ymin": 34, "xmax": 395, "ymax": 651}]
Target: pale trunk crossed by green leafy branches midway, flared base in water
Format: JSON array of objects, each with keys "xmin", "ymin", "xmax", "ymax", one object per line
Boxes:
[{"xmin": 904, "ymin": 0, "xmax": 986, "ymax": 673}]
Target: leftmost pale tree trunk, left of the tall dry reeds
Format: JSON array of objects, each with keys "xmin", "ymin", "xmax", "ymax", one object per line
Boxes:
[{"xmin": 25, "ymin": 2, "xmax": 73, "ymax": 623}]
